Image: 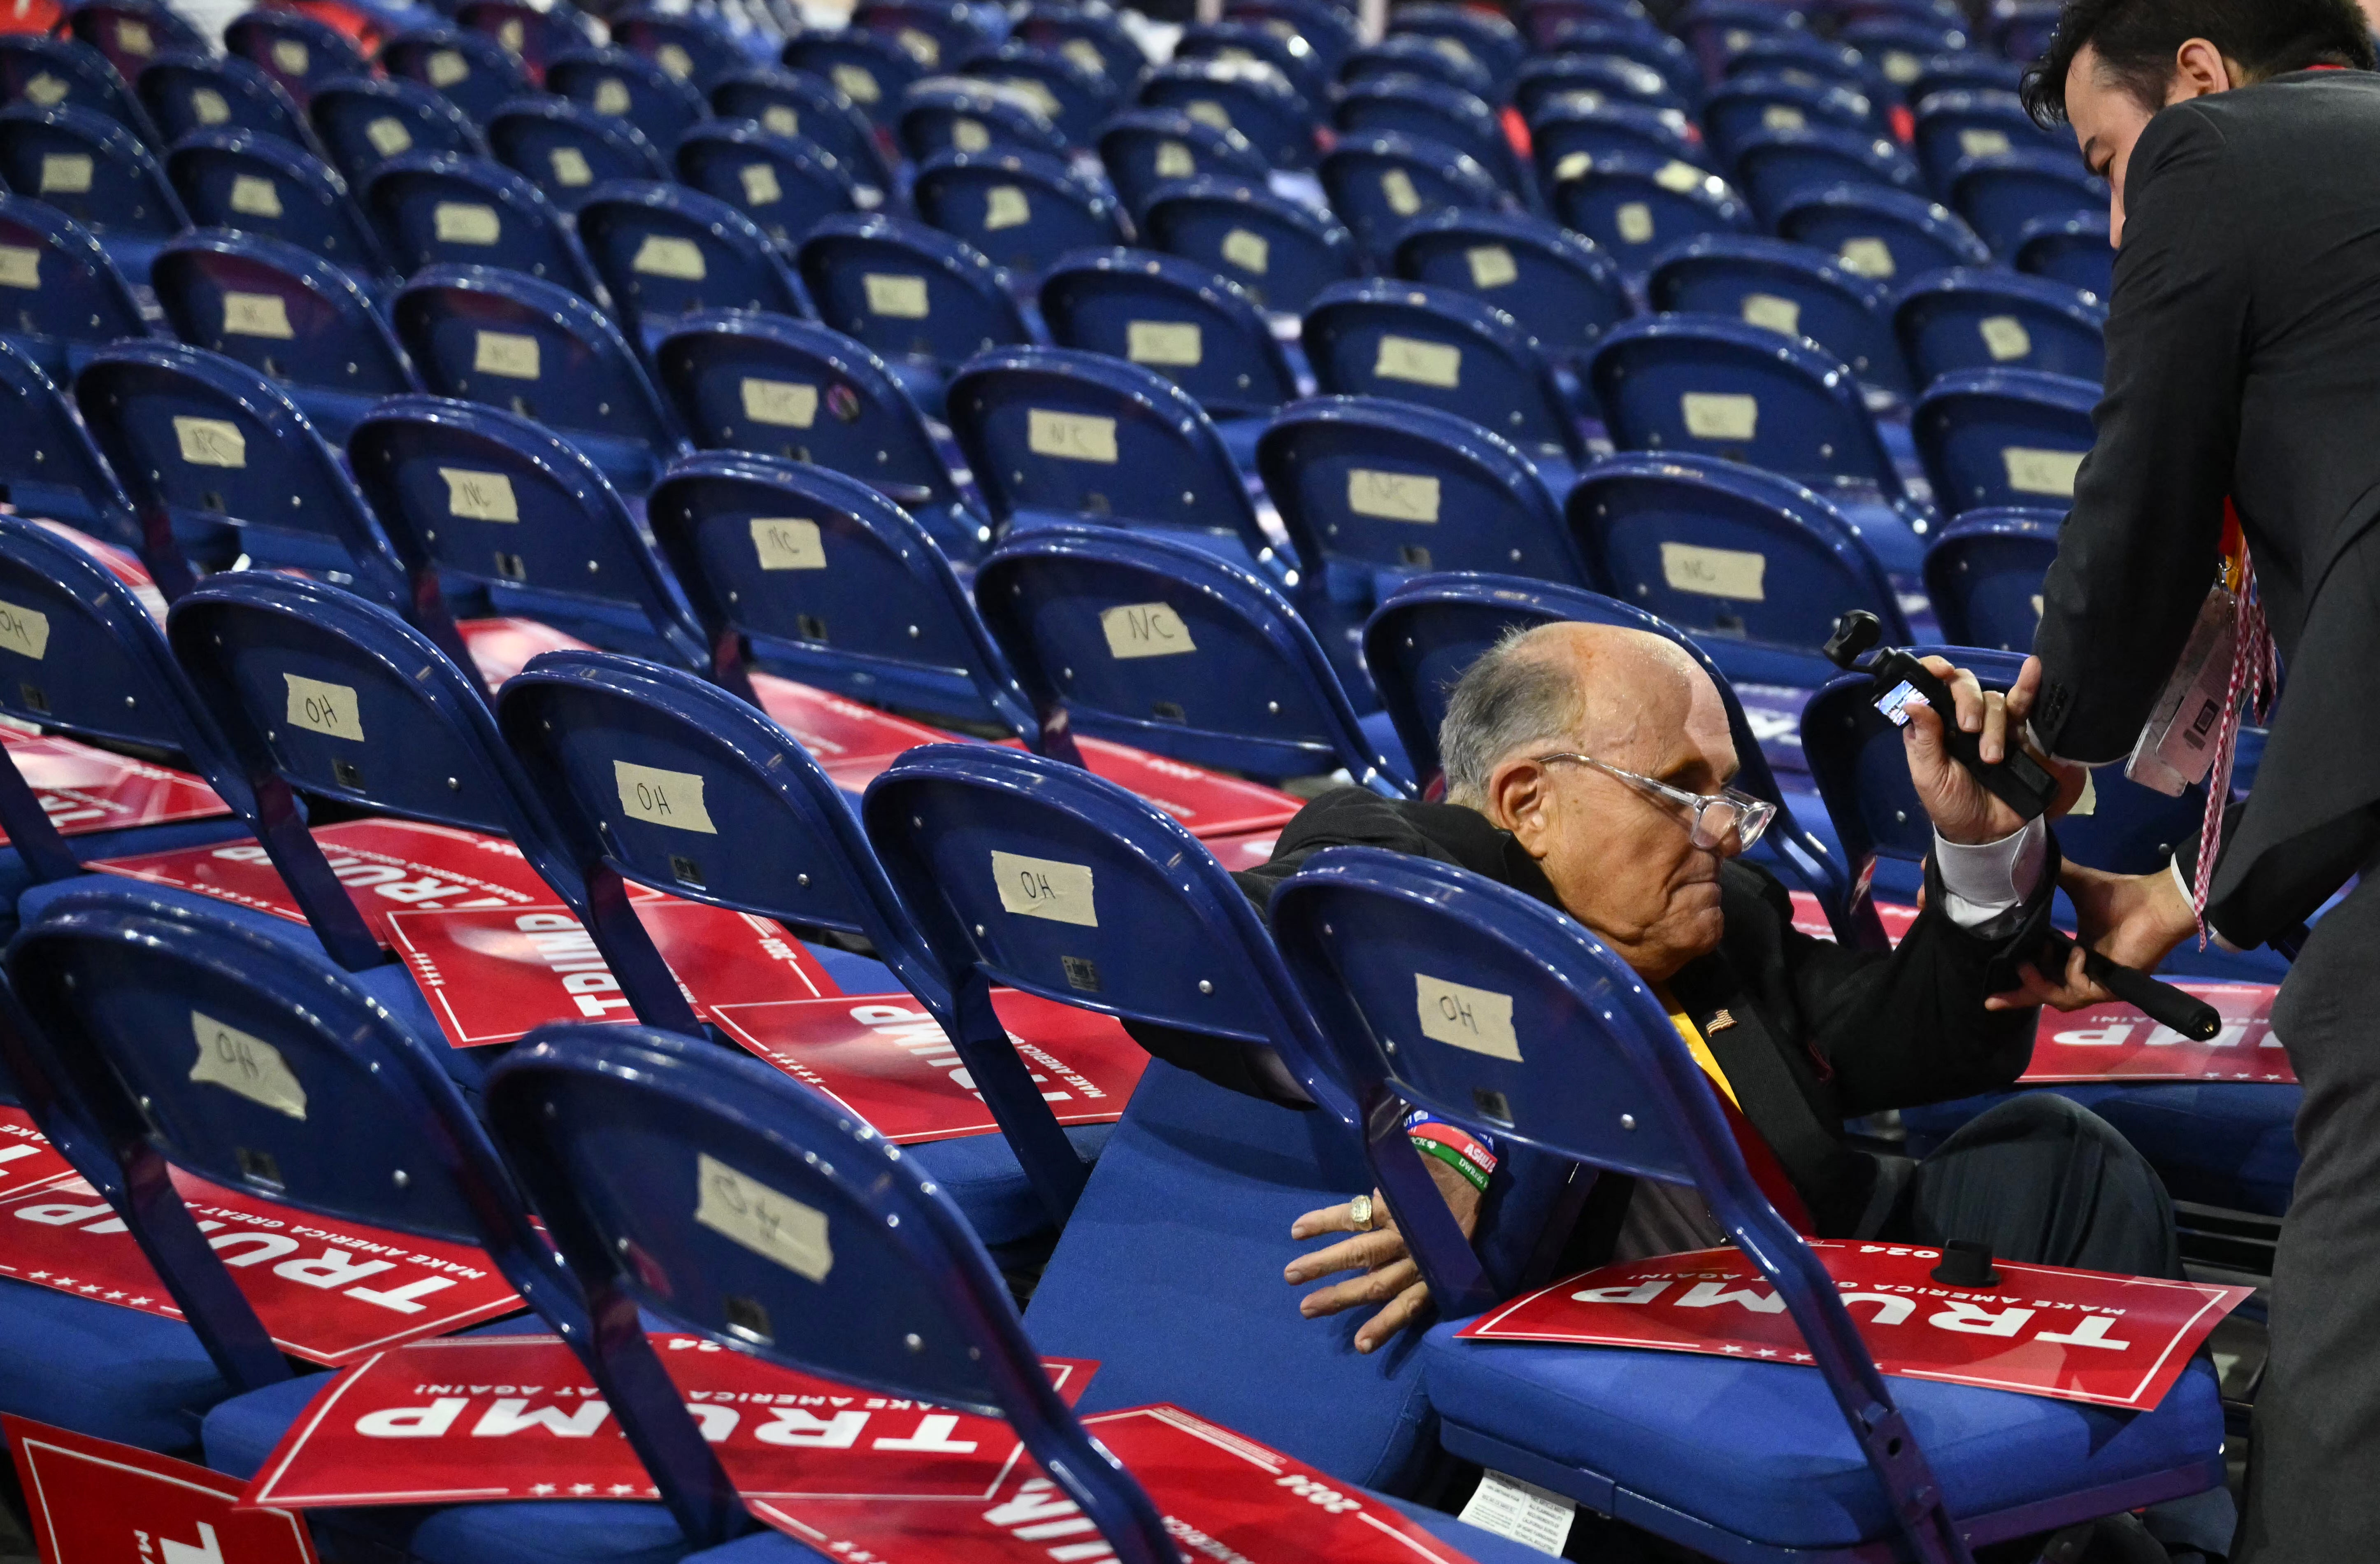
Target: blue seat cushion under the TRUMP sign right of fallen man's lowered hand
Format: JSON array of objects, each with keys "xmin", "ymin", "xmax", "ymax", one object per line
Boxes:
[{"xmin": 1423, "ymin": 1324, "xmax": 2223, "ymax": 1548}]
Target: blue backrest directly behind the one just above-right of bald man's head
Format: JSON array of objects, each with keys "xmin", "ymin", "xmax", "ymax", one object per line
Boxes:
[{"xmin": 1587, "ymin": 314, "xmax": 1901, "ymax": 498}]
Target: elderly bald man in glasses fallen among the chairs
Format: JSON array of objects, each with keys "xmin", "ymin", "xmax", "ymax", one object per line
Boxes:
[{"xmin": 1238, "ymin": 624, "xmax": 2180, "ymax": 1352}]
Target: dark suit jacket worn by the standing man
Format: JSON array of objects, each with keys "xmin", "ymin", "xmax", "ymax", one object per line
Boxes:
[{"xmin": 2033, "ymin": 72, "xmax": 2380, "ymax": 945}]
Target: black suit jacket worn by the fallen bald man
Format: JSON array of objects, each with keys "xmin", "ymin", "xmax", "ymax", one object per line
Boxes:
[{"xmin": 1218, "ymin": 788, "xmax": 2054, "ymax": 1238}]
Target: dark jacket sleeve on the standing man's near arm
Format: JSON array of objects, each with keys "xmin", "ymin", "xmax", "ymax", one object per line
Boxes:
[{"xmin": 2033, "ymin": 105, "xmax": 2256, "ymax": 764}]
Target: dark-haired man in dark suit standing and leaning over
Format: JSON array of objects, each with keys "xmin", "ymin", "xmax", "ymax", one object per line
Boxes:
[{"xmin": 2025, "ymin": 0, "xmax": 2380, "ymax": 1564}]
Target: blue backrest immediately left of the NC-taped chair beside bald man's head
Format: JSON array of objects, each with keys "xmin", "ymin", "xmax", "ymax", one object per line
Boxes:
[{"xmin": 645, "ymin": 452, "xmax": 1042, "ymax": 724}]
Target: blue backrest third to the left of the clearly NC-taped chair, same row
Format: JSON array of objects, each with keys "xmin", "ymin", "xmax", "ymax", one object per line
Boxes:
[{"xmin": 74, "ymin": 340, "xmax": 440, "ymax": 600}]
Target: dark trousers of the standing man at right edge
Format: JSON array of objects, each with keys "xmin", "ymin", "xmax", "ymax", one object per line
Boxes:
[{"xmin": 2235, "ymin": 871, "xmax": 2380, "ymax": 1564}]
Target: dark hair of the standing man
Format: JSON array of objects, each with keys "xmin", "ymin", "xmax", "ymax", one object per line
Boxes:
[{"xmin": 2023, "ymin": 0, "xmax": 2373, "ymax": 126}]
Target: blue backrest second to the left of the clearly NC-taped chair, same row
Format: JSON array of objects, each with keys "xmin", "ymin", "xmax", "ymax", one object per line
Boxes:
[{"xmin": 347, "ymin": 398, "xmax": 709, "ymax": 666}]
